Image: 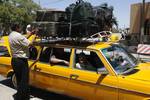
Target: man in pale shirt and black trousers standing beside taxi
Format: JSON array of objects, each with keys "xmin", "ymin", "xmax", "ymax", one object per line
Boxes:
[{"xmin": 9, "ymin": 24, "xmax": 35, "ymax": 100}]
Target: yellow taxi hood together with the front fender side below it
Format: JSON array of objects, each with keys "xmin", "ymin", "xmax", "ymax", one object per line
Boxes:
[{"xmin": 118, "ymin": 63, "xmax": 150, "ymax": 95}]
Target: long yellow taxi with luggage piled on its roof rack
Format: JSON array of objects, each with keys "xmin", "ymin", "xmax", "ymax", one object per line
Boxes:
[{"xmin": 0, "ymin": 36, "xmax": 150, "ymax": 100}]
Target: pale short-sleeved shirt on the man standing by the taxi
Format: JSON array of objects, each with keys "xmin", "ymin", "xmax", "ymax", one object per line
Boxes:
[{"xmin": 9, "ymin": 31, "xmax": 30, "ymax": 58}]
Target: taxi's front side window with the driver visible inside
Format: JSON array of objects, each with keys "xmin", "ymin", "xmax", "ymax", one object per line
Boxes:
[{"xmin": 75, "ymin": 49, "xmax": 106, "ymax": 72}]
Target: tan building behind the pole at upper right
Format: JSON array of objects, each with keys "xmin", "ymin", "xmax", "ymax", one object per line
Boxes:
[{"xmin": 130, "ymin": 2, "xmax": 150, "ymax": 35}]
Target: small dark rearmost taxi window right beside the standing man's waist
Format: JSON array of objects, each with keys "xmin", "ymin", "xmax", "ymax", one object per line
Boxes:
[{"xmin": 29, "ymin": 46, "xmax": 38, "ymax": 60}]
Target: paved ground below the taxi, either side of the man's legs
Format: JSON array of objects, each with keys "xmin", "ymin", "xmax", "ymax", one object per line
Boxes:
[{"xmin": 0, "ymin": 75, "xmax": 78, "ymax": 100}]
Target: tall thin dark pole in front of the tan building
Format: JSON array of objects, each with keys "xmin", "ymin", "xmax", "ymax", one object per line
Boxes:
[{"xmin": 140, "ymin": 0, "xmax": 145, "ymax": 43}]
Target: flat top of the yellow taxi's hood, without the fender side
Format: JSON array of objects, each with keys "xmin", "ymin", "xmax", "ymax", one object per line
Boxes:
[{"xmin": 126, "ymin": 62, "xmax": 150, "ymax": 82}]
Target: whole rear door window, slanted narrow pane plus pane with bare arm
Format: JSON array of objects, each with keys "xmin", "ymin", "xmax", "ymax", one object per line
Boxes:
[{"xmin": 39, "ymin": 47, "xmax": 71, "ymax": 67}]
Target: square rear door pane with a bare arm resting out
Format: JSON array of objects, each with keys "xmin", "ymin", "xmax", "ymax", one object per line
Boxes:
[{"xmin": 50, "ymin": 48, "xmax": 71, "ymax": 67}]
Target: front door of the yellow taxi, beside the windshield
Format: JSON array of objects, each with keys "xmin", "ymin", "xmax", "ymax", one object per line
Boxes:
[{"xmin": 68, "ymin": 49, "xmax": 118, "ymax": 100}]
